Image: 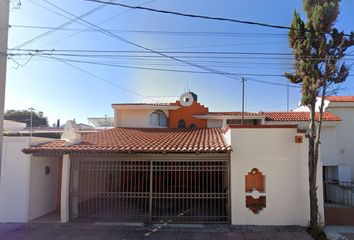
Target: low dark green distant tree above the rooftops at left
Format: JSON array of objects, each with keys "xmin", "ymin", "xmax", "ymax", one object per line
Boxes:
[{"xmin": 4, "ymin": 110, "xmax": 48, "ymax": 127}]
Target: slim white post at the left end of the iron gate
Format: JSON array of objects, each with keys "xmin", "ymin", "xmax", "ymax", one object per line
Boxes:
[{"xmin": 60, "ymin": 154, "xmax": 70, "ymax": 223}]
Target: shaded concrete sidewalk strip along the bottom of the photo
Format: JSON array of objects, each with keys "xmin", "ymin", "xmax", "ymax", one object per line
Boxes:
[{"xmin": 0, "ymin": 223, "xmax": 312, "ymax": 240}]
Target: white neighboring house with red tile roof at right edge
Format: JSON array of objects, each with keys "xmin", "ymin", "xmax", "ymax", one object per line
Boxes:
[{"xmin": 294, "ymin": 96, "xmax": 354, "ymax": 182}]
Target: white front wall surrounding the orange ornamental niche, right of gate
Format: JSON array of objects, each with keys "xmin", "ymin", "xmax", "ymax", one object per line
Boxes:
[{"xmin": 230, "ymin": 128, "xmax": 323, "ymax": 226}]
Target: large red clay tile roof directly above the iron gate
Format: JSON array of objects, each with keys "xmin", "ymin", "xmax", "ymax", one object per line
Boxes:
[{"xmin": 23, "ymin": 128, "xmax": 231, "ymax": 153}]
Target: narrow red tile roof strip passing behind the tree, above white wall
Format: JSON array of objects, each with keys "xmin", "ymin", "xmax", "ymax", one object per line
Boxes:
[{"xmin": 264, "ymin": 112, "xmax": 341, "ymax": 122}]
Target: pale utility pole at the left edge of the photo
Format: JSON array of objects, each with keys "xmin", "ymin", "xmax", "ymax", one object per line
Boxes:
[{"xmin": 0, "ymin": 0, "xmax": 10, "ymax": 182}]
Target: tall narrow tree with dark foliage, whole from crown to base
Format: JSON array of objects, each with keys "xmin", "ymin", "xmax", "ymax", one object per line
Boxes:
[{"xmin": 285, "ymin": 0, "xmax": 354, "ymax": 231}]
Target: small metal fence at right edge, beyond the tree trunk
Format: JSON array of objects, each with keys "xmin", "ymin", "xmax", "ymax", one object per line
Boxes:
[{"xmin": 324, "ymin": 182, "xmax": 354, "ymax": 208}]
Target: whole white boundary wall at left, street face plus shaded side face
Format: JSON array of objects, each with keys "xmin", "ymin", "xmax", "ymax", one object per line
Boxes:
[{"xmin": 0, "ymin": 137, "xmax": 57, "ymax": 223}]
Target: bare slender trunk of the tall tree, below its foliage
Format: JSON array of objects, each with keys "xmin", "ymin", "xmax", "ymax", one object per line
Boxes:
[{"xmin": 308, "ymin": 97, "xmax": 318, "ymax": 230}]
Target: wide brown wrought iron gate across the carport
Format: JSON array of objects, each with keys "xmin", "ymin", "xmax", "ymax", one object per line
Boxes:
[{"xmin": 70, "ymin": 158, "xmax": 230, "ymax": 223}]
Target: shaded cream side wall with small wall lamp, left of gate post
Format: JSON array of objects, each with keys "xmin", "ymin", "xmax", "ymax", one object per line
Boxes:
[{"xmin": 28, "ymin": 156, "xmax": 59, "ymax": 220}]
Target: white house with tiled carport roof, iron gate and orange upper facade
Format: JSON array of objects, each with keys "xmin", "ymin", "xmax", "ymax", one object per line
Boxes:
[{"xmin": 13, "ymin": 93, "xmax": 324, "ymax": 226}]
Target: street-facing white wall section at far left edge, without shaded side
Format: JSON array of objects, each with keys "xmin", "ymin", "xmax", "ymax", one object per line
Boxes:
[{"xmin": 0, "ymin": 137, "xmax": 30, "ymax": 222}]
